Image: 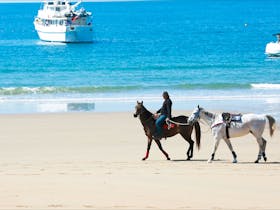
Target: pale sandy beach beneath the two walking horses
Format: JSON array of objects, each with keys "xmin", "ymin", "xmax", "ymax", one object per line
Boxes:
[{"xmin": 0, "ymin": 111, "xmax": 280, "ymax": 209}]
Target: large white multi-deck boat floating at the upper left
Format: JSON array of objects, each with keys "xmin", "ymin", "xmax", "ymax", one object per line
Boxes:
[{"xmin": 34, "ymin": 0, "xmax": 93, "ymax": 43}]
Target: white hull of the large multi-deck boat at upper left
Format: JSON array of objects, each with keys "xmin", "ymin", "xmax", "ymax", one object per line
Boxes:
[{"xmin": 35, "ymin": 24, "xmax": 93, "ymax": 43}]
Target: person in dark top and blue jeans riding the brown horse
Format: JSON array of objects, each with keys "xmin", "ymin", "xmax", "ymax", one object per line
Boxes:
[{"xmin": 154, "ymin": 91, "xmax": 172, "ymax": 140}]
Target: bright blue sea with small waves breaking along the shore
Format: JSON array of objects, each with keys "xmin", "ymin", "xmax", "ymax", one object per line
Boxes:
[{"xmin": 0, "ymin": 0, "xmax": 280, "ymax": 119}]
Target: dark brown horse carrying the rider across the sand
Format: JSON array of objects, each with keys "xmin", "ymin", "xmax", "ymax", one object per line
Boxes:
[{"xmin": 134, "ymin": 101, "xmax": 201, "ymax": 160}]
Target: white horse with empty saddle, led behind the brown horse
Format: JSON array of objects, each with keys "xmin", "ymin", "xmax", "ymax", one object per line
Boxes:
[{"xmin": 188, "ymin": 106, "xmax": 276, "ymax": 163}]
